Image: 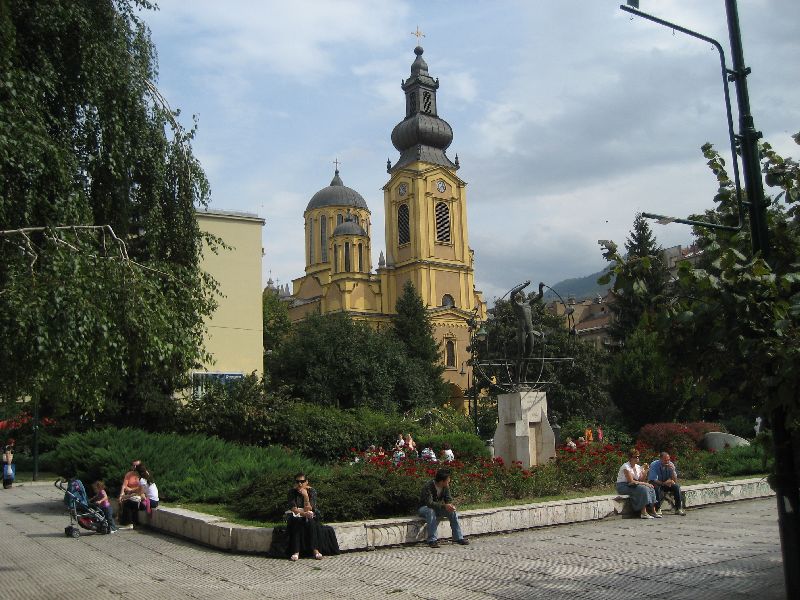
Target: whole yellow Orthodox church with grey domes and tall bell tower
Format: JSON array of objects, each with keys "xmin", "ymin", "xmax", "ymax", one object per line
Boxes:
[{"xmin": 287, "ymin": 46, "xmax": 486, "ymax": 398}]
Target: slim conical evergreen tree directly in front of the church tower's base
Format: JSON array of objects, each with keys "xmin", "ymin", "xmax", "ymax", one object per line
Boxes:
[{"xmin": 392, "ymin": 281, "xmax": 450, "ymax": 406}]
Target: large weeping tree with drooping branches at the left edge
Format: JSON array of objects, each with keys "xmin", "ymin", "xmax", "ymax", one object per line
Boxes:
[{"xmin": 0, "ymin": 0, "xmax": 215, "ymax": 428}]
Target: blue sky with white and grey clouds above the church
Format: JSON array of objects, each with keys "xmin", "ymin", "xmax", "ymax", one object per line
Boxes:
[{"xmin": 143, "ymin": 0, "xmax": 800, "ymax": 300}]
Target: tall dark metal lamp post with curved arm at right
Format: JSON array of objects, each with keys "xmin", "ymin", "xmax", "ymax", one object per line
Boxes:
[{"xmin": 620, "ymin": 0, "xmax": 800, "ymax": 598}]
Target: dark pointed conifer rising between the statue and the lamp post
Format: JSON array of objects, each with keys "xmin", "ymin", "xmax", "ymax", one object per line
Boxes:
[{"xmin": 599, "ymin": 214, "xmax": 669, "ymax": 342}]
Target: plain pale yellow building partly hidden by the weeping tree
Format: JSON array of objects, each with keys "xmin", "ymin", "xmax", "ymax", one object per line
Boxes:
[{"xmin": 192, "ymin": 210, "xmax": 264, "ymax": 393}]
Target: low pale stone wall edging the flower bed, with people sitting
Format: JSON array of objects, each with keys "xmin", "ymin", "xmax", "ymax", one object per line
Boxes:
[{"xmin": 144, "ymin": 479, "xmax": 774, "ymax": 553}]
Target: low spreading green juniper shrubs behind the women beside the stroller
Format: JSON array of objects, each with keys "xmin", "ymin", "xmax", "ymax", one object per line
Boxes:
[{"xmin": 42, "ymin": 428, "xmax": 325, "ymax": 503}]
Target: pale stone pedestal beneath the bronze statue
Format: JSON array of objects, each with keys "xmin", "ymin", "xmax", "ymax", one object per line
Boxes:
[{"xmin": 494, "ymin": 390, "xmax": 556, "ymax": 468}]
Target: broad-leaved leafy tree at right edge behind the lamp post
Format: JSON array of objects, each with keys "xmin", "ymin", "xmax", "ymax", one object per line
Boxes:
[{"xmin": 606, "ymin": 134, "xmax": 800, "ymax": 428}]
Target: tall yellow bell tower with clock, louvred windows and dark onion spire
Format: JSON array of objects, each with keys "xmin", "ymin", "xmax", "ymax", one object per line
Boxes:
[{"xmin": 379, "ymin": 46, "xmax": 482, "ymax": 313}]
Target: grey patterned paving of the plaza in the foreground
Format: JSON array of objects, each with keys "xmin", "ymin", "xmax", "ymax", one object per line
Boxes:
[{"xmin": 0, "ymin": 483, "xmax": 785, "ymax": 600}]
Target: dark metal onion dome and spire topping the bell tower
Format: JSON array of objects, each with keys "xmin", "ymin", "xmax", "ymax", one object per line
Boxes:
[{"xmin": 389, "ymin": 46, "xmax": 458, "ymax": 172}]
